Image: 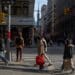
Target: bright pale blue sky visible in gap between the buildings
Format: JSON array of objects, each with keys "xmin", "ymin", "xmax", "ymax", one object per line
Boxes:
[{"xmin": 34, "ymin": 0, "xmax": 47, "ymax": 21}]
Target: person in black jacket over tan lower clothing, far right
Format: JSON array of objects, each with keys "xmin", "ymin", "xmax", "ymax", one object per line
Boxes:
[{"xmin": 62, "ymin": 39, "xmax": 74, "ymax": 70}]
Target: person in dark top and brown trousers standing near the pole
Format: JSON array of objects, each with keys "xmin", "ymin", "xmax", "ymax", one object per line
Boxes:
[{"xmin": 15, "ymin": 32, "xmax": 24, "ymax": 62}]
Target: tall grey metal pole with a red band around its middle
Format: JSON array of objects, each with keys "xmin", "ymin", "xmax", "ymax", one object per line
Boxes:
[{"xmin": 6, "ymin": 4, "xmax": 12, "ymax": 62}]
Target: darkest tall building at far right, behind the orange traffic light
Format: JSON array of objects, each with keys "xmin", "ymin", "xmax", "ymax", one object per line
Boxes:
[{"xmin": 55, "ymin": 0, "xmax": 75, "ymax": 39}]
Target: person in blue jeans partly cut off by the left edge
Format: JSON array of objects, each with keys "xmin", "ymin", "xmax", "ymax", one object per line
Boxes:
[{"xmin": 0, "ymin": 34, "xmax": 8, "ymax": 65}]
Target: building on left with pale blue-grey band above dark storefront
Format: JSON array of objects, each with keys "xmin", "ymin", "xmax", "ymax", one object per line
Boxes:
[{"xmin": 0, "ymin": 0, "xmax": 35, "ymax": 45}]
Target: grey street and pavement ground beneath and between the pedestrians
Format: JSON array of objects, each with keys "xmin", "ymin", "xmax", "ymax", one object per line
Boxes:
[{"xmin": 0, "ymin": 46, "xmax": 75, "ymax": 75}]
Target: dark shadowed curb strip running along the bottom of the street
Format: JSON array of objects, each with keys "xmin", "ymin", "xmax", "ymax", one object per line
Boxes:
[{"xmin": 0, "ymin": 64, "xmax": 74, "ymax": 75}]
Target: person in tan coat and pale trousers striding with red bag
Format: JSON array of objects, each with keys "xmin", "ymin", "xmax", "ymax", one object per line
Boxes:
[{"xmin": 35, "ymin": 36, "xmax": 52, "ymax": 69}]
